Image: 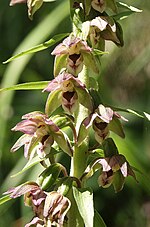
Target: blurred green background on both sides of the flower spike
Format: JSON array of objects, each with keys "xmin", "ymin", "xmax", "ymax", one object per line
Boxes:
[{"xmin": 0, "ymin": 0, "xmax": 150, "ymax": 227}]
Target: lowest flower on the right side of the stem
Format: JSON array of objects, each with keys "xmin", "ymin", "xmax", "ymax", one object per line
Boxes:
[{"xmin": 93, "ymin": 154, "xmax": 136, "ymax": 192}]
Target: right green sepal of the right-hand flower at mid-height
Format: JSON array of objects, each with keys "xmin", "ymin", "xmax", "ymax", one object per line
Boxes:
[{"xmin": 108, "ymin": 116, "xmax": 125, "ymax": 138}]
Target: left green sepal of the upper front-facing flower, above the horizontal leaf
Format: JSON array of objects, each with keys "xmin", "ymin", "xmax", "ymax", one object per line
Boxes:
[{"xmin": 54, "ymin": 54, "xmax": 67, "ymax": 77}]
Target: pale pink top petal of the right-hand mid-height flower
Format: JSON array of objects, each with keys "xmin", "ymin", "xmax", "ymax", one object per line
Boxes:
[{"xmin": 98, "ymin": 104, "xmax": 114, "ymax": 123}]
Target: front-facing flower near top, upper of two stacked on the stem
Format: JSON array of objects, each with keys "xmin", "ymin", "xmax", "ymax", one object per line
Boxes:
[{"xmin": 52, "ymin": 35, "xmax": 98, "ymax": 76}]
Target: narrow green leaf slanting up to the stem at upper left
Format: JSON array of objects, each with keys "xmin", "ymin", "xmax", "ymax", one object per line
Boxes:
[{"xmin": 3, "ymin": 33, "xmax": 69, "ymax": 64}]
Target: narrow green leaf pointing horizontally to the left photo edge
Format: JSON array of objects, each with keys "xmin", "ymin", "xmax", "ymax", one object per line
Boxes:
[{"xmin": 0, "ymin": 81, "xmax": 49, "ymax": 92}]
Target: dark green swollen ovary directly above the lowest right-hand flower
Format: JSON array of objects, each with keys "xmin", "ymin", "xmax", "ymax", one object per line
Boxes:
[{"xmin": 102, "ymin": 138, "xmax": 119, "ymax": 157}]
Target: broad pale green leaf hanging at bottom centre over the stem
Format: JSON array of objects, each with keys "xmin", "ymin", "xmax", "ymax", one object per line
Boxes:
[{"xmin": 73, "ymin": 187, "xmax": 94, "ymax": 227}]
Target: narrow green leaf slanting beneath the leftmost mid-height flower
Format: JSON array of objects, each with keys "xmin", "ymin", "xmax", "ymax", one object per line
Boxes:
[{"xmin": 11, "ymin": 156, "xmax": 45, "ymax": 177}]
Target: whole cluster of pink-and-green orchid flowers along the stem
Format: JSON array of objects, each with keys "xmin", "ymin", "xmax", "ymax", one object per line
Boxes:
[{"xmin": 7, "ymin": 0, "xmax": 135, "ymax": 227}]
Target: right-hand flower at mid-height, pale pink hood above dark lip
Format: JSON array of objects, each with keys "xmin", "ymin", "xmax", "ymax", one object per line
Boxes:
[{"xmin": 80, "ymin": 104, "xmax": 127, "ymax": 144}]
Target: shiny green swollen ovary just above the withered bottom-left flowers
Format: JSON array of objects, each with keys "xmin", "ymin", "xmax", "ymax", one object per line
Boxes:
[{"xmin": 36, "ymin": 163, "xmax": 62, "ymax": 190}]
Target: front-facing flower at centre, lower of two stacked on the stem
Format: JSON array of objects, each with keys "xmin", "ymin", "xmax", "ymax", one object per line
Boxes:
[{"xmin": 44, "ymin": 72, "xmax": 92, "ymax": 115}]
